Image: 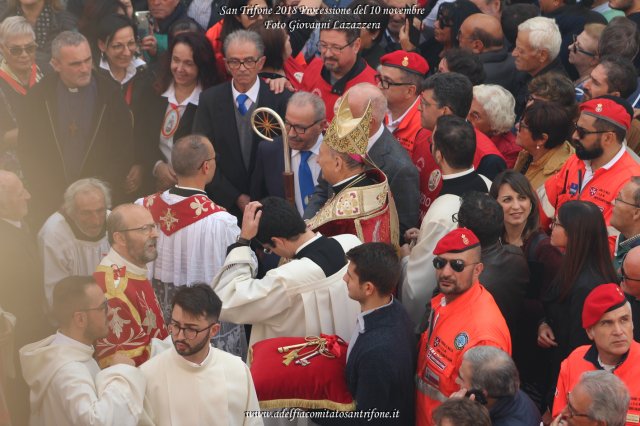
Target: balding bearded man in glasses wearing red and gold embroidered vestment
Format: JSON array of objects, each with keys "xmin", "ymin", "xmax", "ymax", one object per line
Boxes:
[{"xmin": 93, "ymin": 204, "xmax": 167, "ymax": 368}]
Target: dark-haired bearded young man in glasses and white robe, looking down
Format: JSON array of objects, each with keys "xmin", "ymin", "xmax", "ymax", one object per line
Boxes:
[{"xmin": 140, "ymin": 284, "xmax": 262, "ymax": 426}]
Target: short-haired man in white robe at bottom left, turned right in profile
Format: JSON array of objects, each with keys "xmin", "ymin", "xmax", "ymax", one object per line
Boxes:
[{"xmin": 20, "ymin": 276, "xmax": 145, "ymax": 426}]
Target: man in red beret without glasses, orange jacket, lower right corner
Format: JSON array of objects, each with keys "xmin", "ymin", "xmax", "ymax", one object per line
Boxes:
[{"xmin": 553, "ymin": 284, "xmax": 640, "ymax": 425}]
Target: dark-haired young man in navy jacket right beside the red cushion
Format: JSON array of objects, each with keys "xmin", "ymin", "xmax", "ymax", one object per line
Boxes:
[{"xmin": 344, "ymin": 243, "xmax": 416, "ymax": 425}]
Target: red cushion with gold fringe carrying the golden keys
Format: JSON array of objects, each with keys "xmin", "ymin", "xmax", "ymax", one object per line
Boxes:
[{"xmin": 249, "ymin": 336, "xmax": 355, "ymax": 411}]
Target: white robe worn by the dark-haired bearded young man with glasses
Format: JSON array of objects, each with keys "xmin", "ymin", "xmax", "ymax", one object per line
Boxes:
[{"xmin": 139, "ymin": 347, "xmax": 263, "ymax": 426}]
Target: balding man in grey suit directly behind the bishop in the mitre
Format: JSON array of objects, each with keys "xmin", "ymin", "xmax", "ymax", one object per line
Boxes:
[{"xmin": 304, "ymin": 83, "xmax": 420, "ymax": 240}]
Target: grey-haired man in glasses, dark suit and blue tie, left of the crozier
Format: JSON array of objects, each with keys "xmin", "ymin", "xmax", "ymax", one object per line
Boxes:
[{"xmin": 193, "ymin": 30, "xmax": 291, "ymax": 220}]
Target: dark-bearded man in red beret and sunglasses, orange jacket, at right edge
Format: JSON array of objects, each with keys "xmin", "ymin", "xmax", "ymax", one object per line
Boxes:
[{"xmin": 538, "ymin": 96, "xmax": 640, "ymax": 247}]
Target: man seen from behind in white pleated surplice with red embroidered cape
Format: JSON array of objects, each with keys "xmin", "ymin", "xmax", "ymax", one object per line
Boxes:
[{"xmin": 136, "ymin": 135, "xmax": 247, "ymax": 356}]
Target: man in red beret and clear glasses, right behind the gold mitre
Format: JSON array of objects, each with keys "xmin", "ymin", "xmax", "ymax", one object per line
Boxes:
[{"xmin": 376, "ymin": 50, "xmax": 429, "ymax": 155}]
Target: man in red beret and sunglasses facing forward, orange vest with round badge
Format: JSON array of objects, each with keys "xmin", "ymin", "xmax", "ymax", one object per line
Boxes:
[{"xmin": 416, "ymin": 228, "xmax": 511, "ymax": 425}]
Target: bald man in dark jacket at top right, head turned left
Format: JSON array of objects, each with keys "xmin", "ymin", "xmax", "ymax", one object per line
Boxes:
[{"xmin": 458, "ymin": 14, "xmax": 520, "ymax": 96}]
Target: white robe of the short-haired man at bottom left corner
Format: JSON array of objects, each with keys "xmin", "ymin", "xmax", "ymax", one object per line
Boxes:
[{"xmin": 20, "ymin": 332, "xmax": 145, "ymax": 426}]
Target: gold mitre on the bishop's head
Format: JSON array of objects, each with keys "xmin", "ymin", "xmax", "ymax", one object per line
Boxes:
[{"xmin": 323, "ymin": 94, "xmax": 372, "ymax": 155}]
